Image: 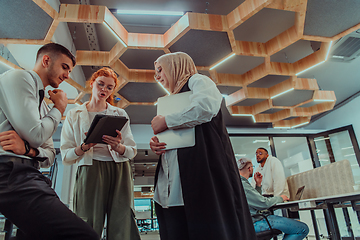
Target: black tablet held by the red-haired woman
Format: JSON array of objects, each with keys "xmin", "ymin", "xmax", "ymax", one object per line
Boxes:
[{"xmin": 84, "ymin": 114, "xmax": 128, "ymax": 144}]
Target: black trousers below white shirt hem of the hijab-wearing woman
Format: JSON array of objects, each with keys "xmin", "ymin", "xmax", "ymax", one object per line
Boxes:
[{"xmin": 155, "ymin": 203, "xmax": 190, "ymax": 240}]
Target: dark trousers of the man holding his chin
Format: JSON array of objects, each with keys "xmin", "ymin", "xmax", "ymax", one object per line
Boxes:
[{"xmin": 0, "ymin": 162, "xmax": 100, "ymax": 240}]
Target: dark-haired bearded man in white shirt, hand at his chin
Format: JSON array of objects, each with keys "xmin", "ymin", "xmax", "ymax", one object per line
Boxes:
[{"xmin": 0, "ymin": 43, "xmax": 99, "ymax": 240}]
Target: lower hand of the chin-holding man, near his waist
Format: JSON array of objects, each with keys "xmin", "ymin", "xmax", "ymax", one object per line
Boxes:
[{"xmin": 0, "ymin": 130, "xmax": 26, "ymax": 155}]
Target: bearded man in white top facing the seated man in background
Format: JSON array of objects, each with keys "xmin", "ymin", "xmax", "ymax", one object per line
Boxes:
[{"xmin": 251, "ymin": 147, "xmax": 290, "ymax": 197}]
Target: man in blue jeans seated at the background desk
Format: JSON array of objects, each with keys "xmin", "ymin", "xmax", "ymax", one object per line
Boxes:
[{"xmin": 237, "ymin": 158, "xmax": 309, "ymax": 240}]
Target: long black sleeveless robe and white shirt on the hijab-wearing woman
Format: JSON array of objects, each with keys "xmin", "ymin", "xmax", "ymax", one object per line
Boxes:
[{"xmin": 154, "ymin": 74, "xmax": 256, "ymax": 240}]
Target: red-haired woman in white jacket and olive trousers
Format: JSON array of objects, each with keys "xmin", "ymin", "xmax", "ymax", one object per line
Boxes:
[{"xmin": 61, "ymin": 67, "xmax": 140, "ymax": 240}]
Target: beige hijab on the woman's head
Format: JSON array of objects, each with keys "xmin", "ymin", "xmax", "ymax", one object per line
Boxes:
[{"xmin": 154, "ymin": 52, "xmax": 197, "ymax": 94}]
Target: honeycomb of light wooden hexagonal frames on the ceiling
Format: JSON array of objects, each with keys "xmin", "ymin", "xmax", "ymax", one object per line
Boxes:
[{"xmin": 0, "ymin": 0, "xmax": 360, "ymax": 128}]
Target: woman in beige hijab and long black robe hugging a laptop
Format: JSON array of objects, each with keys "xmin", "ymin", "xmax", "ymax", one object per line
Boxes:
[{"xmin": 150, "ymin": 52, "xmax": 256, "ymax": 240}]
